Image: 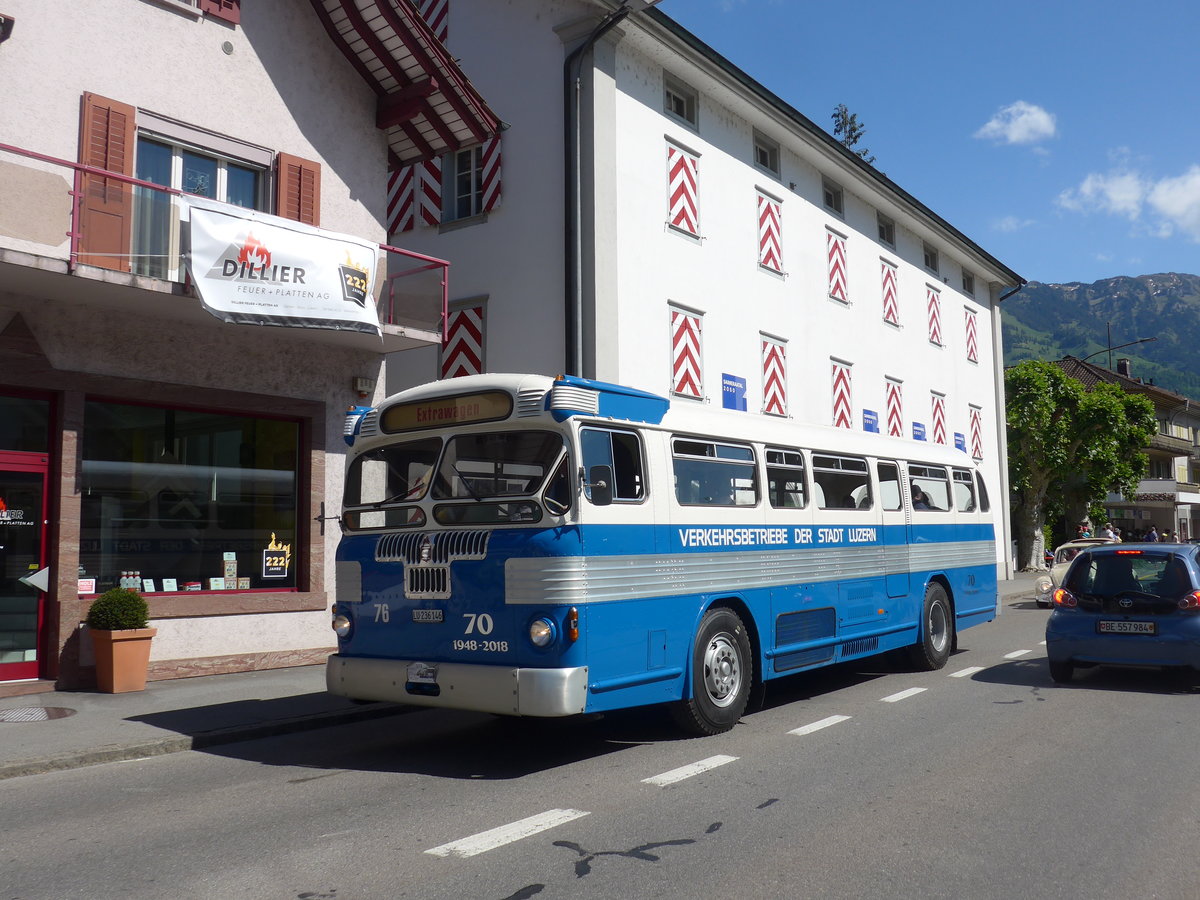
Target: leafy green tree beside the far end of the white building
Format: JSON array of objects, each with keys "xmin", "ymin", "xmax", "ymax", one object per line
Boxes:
[{"xmin": 1004, "ymin": 360, "xmax": 1158, "ymax": 570}]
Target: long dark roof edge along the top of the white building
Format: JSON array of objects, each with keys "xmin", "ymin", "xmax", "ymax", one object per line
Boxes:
[{"xmin": 638, "ymin": 7, "xmax": 1026, "ymax": 286}]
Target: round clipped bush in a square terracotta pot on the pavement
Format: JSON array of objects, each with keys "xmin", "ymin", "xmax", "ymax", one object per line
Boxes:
[{"xmin": 85, "ymin": 588, "xmax": 158, "ymax": 694}]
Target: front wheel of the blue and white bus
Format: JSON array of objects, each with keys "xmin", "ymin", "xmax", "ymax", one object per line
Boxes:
[{"xmin": 672, "ymin": 607, "xmax": 754, "ymax": 734}]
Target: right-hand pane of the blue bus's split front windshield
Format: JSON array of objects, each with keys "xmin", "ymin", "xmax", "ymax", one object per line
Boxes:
[{"xmin": 433, "ymin": 431, "xmax": 563, "ymax": 500}]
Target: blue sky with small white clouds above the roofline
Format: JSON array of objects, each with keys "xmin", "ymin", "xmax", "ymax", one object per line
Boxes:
[{"xmin": 658, "ymin": 0, "xmax": 1200, "ymax": 283}]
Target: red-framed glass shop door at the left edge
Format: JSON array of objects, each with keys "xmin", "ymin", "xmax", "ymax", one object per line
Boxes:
[{"xmin": 0, "ymin": 452, "xmax": 47, "ymax": 682}]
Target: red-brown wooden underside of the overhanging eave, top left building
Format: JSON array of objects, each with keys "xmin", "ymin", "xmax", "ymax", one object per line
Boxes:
[{"xmin": 310, "ymin": 0, "xmax": 502, "ymax": 169}]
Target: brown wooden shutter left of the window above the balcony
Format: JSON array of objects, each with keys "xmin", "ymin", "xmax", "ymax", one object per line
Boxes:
[{"xmin": 76, "ymin": 94, "xmax": 137, "ymax": 272}]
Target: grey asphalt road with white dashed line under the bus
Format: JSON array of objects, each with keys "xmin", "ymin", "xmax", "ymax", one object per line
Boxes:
[{"xmin": 0, "ymin": 601, "xmax": 1200, "ymax": 900}]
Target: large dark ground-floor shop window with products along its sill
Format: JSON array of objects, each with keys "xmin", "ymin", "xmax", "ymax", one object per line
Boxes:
[{"xmin": 79, "ymin": 401, "xmax": 300, "ymax": 594}]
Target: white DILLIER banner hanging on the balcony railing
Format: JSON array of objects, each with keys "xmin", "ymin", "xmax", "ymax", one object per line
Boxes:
[{"xmin": 180, "ymin": 197, "xmax": 380, "ymax": 335}]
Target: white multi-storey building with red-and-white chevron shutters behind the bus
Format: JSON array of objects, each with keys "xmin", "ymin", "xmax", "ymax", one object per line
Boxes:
[{"xmin": 388, "ymin": 0, "xmax": 1024, "ymax": 572}]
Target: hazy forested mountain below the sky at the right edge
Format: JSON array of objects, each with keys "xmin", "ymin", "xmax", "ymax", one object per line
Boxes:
[{"xmin": 1000, "ymin": 272, "xmax": 1200, "ymax": 400}]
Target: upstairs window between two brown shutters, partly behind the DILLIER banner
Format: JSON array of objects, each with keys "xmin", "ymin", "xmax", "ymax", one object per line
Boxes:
[{"xmin": 132, "ymin": 133, "xmax": 268, "ymax": 281}]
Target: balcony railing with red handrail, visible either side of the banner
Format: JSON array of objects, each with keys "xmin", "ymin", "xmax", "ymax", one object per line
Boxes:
[{"xmin": 0, "ymin": 144, "xmax": 450, "ymax": 349}]
